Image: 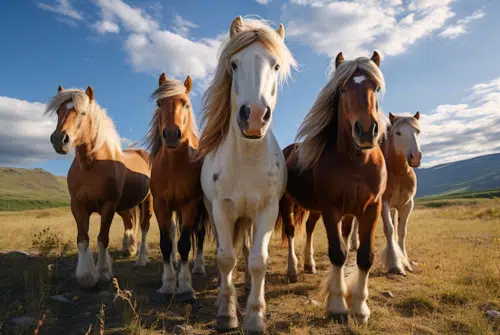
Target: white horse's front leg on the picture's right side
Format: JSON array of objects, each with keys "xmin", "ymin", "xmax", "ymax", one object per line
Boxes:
[{"xmin": 244, "ymin": 203, "xmax": 279, "ymax": 334}]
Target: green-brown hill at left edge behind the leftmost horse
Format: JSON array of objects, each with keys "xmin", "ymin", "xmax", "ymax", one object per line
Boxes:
[{"xmin": 0, "ymin": 167, "xmax": 69, "ymax": 211}]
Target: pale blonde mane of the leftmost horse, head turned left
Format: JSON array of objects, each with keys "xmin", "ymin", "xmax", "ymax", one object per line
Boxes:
[{"xmin": 45, "ymin": 88, "xmax": 122, "ymax": 159}]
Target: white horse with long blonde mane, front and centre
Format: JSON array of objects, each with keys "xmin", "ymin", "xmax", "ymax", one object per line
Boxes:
[{"xmin": 197, "ymin": 16, "xmax": 296, "ymax": 334}]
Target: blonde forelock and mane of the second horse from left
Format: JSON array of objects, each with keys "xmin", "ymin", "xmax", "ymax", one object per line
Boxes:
[{"xmin": 145, "ymin": 78, "xmax": 199, "ymax": 158}]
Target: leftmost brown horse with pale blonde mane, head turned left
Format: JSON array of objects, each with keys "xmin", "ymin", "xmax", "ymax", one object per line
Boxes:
[{"xmin": 45, "ymin": 86, "xmax": 152, "ymax": 288}]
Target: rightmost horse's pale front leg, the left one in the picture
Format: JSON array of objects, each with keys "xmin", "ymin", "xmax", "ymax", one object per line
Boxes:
[{"xmin": 380, "ymin": 200, "xmax": 406, "ymax": 276}]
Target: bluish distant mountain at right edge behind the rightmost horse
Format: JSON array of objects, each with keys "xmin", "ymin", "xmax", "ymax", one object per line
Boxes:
[{"xmin": 415, "ymin": 154, "xmax": 500, "ymax": 197}]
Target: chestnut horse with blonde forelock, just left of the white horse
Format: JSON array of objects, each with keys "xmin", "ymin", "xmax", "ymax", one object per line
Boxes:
[{"xmin": 147, "ymin": 73, "xmax": 207, "ymax": 301}]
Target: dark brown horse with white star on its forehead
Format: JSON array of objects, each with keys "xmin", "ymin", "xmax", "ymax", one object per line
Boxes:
[{"xmin": 280, "ymin": 52, "xmax": 387, "ymax": 323}]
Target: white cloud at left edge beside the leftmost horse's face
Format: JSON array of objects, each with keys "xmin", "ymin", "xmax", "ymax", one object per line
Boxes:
[{"xmin": 0, "ymin": 96, "xmax": 60, "ymax": 166}]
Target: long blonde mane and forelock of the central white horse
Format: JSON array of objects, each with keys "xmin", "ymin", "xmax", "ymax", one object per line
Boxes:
[{"xmin": 198, "ymin": 18, "xmax": 297, "ymax": 158}]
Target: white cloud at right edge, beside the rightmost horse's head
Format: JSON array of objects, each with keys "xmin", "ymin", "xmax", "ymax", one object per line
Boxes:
[{"xmin": 420, "ymin": 77, "xmax": 500, "ymax": 166}]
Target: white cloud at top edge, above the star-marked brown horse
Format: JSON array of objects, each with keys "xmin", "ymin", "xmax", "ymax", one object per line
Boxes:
[{"xmin": 284, "ymin": 0, "xmax": 455, "ymax": 58}]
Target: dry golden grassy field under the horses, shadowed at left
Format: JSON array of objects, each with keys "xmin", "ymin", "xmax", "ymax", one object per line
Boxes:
[{"xmin": 0, "ymin": 199, "xmax": 500, "ymax": 335}]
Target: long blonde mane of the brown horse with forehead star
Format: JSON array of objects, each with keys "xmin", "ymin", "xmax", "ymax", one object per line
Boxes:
[{"xmin": 296, "ymin": 57, "xmax": 386, "ymax": 171}]
